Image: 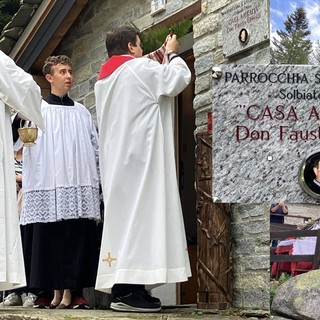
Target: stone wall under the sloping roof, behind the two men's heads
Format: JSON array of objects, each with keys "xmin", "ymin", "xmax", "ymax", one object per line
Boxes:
[{"xmin": 56, "ymin": 0, "xmax": 196, "ymax": 119}]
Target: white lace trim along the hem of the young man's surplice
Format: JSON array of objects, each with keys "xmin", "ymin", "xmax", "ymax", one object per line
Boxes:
[{"xmin": 20, "ymin": 186, "xmax": 100, "ymax": 225}]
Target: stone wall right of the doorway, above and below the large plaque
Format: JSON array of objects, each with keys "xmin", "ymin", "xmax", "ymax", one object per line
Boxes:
[{"xmin": 193, "ymin": 0, "xmax": 270, "ymax": 309}]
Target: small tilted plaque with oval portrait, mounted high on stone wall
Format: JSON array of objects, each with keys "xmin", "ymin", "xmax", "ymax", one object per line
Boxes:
[{"xmin": 221, "ymin": 0, "xmax": 270, "ymax": 57}]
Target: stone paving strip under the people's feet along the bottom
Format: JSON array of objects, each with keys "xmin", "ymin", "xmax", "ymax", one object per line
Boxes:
[{"xmin": 0, "ymin": 307, "xmax": 269, "ymax": 320}]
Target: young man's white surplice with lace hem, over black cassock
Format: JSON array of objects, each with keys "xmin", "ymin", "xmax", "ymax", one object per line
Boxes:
[{"xmin": 20, "ymin": 101, "xmax": 100, "ymax": 225}]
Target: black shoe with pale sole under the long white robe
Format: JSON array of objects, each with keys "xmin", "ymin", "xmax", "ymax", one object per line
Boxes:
[{"xmin": 110, "ymin": 291, "xmax": 161, "ymax": 312}]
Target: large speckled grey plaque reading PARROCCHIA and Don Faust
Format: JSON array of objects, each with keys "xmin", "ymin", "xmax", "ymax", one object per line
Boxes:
[{"xmin": 212, "ymin": 65, "xmax": 320, "ymax": 203}]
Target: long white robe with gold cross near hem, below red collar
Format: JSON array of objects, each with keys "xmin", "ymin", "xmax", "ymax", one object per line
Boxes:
[{"xmin": 95, "ymin": 57, "xmax": 191, "ymax": 292}]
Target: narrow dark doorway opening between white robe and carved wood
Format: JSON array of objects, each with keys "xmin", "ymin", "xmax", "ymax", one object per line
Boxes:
[{"xmin": 176, "ymin": 50, "xmax": 198, "ymax": 304}]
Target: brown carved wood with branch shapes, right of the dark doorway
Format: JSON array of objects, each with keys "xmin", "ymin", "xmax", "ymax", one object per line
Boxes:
[{"xmin": 196, "ymin": 133, "xmax": 232, "ymax": 310}]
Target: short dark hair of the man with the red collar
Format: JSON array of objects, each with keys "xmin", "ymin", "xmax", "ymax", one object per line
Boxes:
[{"xmin": 106, "ymin": 26, "xmax": 139, "ymax": 58}]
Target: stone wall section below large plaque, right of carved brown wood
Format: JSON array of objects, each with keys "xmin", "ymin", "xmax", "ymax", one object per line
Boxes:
[{"xmin": 231, "ymin": 203, "xmax": 270, "ymax": 309}]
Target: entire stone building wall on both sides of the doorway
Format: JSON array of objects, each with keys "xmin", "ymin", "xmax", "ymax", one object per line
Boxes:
[{"xmin": 56, "ymin": 0, "xmax": 269, "ymax": 309}]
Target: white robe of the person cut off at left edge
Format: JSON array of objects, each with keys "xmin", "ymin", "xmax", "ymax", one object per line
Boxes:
[{"xmin": 0, "ymin": 51, "xmax": 44, "ymax": 290}]
